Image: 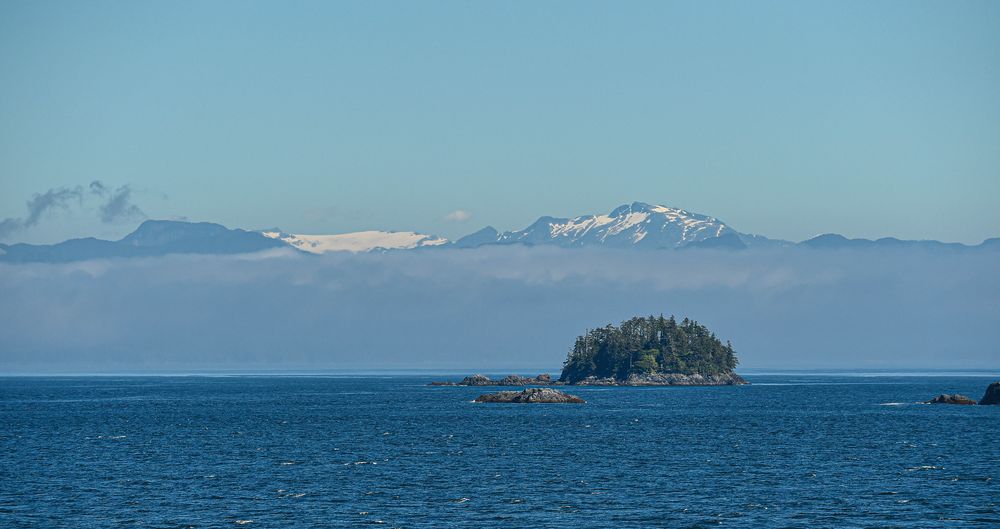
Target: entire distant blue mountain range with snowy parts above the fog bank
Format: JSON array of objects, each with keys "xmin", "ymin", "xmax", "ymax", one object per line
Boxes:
[{"xmin": 0, "ymin": 202, "xmax": 1000, "ymax": 263}]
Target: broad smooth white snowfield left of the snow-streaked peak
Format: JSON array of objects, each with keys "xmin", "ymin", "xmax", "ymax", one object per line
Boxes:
[{"xmin": 261, "ymin": 229, "xmax": 448, "ymax": 253}]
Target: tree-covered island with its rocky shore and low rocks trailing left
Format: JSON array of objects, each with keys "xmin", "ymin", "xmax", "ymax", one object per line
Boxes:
[{"xmin": 431, "ymin": 314, "xmax": 749, "ymax": 386}]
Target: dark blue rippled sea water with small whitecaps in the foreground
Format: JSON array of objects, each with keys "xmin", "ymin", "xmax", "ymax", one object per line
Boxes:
[{"xmin": 0, "ymin": 376, "xmax": 1000, "ymax": 528}]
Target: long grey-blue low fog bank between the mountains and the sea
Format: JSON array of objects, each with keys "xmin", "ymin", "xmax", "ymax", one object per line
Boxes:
[{"xmin": 0, "ymin": 247, "xmax": 1000, "ymax": 372}]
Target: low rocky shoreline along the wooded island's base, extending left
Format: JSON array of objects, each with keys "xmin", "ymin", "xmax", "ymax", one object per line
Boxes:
[{"xmin": 430, "ymin": 373, "xmax": 750, "ymax": 386}]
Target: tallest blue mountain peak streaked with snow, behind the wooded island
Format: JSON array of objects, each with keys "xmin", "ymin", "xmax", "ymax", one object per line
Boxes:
[{"xmin": 455, "ymin": 202, "xmax": 775, "ymax": 248}]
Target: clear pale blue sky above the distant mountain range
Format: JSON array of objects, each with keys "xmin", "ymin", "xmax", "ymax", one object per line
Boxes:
[{"xmin": 0, "ymin": 1, "xmax": 1000, "ymax": 242}]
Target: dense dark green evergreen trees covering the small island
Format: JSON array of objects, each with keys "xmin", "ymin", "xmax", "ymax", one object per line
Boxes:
[{"xmin": 560, "ymin": 314, "xmax": 738, "ymax": 383}]
